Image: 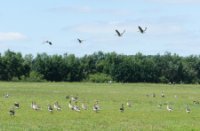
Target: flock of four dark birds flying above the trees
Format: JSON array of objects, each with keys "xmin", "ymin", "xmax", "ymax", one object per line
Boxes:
[{"xmin": 44, "ymin": 26, "xmax": 147, "ymax": 45}]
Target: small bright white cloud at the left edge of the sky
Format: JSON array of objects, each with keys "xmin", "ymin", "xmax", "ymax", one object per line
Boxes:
[{"xmin": 0, "ymin": 32, "xmax": 27, "ymax": 41}]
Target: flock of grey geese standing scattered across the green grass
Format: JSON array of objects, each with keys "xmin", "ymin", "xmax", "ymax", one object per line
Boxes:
[{"xmin": 4, "ymin": 91, "xmax": 197, "ymax": 116}]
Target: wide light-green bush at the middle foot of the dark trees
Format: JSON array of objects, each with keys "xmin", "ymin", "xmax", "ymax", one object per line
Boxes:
[{"xmin": 89, "ymin": 73, "xmax": 112, "ymax": 83}]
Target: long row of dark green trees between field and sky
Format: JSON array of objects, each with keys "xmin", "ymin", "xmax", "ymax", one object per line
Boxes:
[{"xmin": 0, "ymin": 50, "xmax": 200, "ymax": 83}]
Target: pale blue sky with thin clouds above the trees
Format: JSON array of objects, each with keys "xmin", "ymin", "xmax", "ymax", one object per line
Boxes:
[{"xmin": 0, "ymin": 0, "xmax": 200, "ymax": 56}]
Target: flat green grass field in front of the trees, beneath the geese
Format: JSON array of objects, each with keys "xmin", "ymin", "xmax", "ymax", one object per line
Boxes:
[{"xmin": 0, "ymin": 82, "xmax": 200, "ymax": 131}]
